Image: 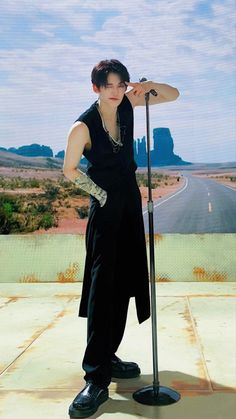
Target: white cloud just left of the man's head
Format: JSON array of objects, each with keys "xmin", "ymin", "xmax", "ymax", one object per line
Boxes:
[{"xmin": 0, "ymin": 42, "xmax": 115, "ymax": 81}]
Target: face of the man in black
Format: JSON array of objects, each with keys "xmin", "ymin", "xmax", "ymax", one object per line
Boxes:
[{"xmin": 95, "ymin": 73, "xmax": 127, "ymax": 107}]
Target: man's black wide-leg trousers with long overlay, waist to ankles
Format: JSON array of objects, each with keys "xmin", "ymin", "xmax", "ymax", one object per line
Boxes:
[{"xmin": 80, "ymin": 177, "xmax": 147, "ymax": 387}]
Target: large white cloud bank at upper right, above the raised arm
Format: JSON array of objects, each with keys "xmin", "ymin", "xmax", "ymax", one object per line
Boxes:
[{"xmin": 78, "ymin": 0, "xmax": 235, "ymax": 76}]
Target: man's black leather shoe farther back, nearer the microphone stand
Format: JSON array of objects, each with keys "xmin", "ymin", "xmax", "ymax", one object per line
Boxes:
[{"xmin": 111, "ymin": 355, "xmax": 141, "ymax": 378}]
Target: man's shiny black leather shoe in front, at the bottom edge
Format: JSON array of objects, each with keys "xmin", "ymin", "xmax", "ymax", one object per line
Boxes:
[{"xmin": 69, "ymin": 382, "xmax": 108, "ymax": 418}]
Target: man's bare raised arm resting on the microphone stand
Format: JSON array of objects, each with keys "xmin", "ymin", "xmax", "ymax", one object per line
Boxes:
[{"xmin": 126, "ymin": 81, "xmax": 179, "ymax": 107}]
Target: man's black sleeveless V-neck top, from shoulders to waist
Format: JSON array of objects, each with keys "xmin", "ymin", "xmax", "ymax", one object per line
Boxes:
[{"xmin": 75, "ymin": 95, "xmax": 137, "ymax": 190}]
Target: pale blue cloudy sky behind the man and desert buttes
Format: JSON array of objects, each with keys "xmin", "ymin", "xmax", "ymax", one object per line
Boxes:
[{"xmin": 0, "ymin": 0, "xmax": 236, "ymax": 162}]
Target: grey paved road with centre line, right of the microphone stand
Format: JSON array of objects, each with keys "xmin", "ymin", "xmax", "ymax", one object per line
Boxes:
[{"xmin": 143, "ymin": 172, "xmax": 236, "ymax": 233}]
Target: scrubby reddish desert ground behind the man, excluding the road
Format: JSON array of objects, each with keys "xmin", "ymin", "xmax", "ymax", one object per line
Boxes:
[{"xmin": 0, "ymin": 159, "xmax": 236, "ymax": 234}]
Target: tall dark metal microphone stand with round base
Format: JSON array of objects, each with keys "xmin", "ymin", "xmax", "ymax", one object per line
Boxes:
[{"xmin": 133, "ymin": 88, "xmax": 181, "ymax": 406}]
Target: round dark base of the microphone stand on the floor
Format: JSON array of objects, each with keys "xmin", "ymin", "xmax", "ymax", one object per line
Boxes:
[{"xmin": 133, "ymin": 385, "xmax": 180, "ymax": 406}]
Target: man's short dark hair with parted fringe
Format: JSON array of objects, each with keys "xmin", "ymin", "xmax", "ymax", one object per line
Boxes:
[{"xmin": 91, "ymin": 59, "xmax": 130, "ymax": 87}]
